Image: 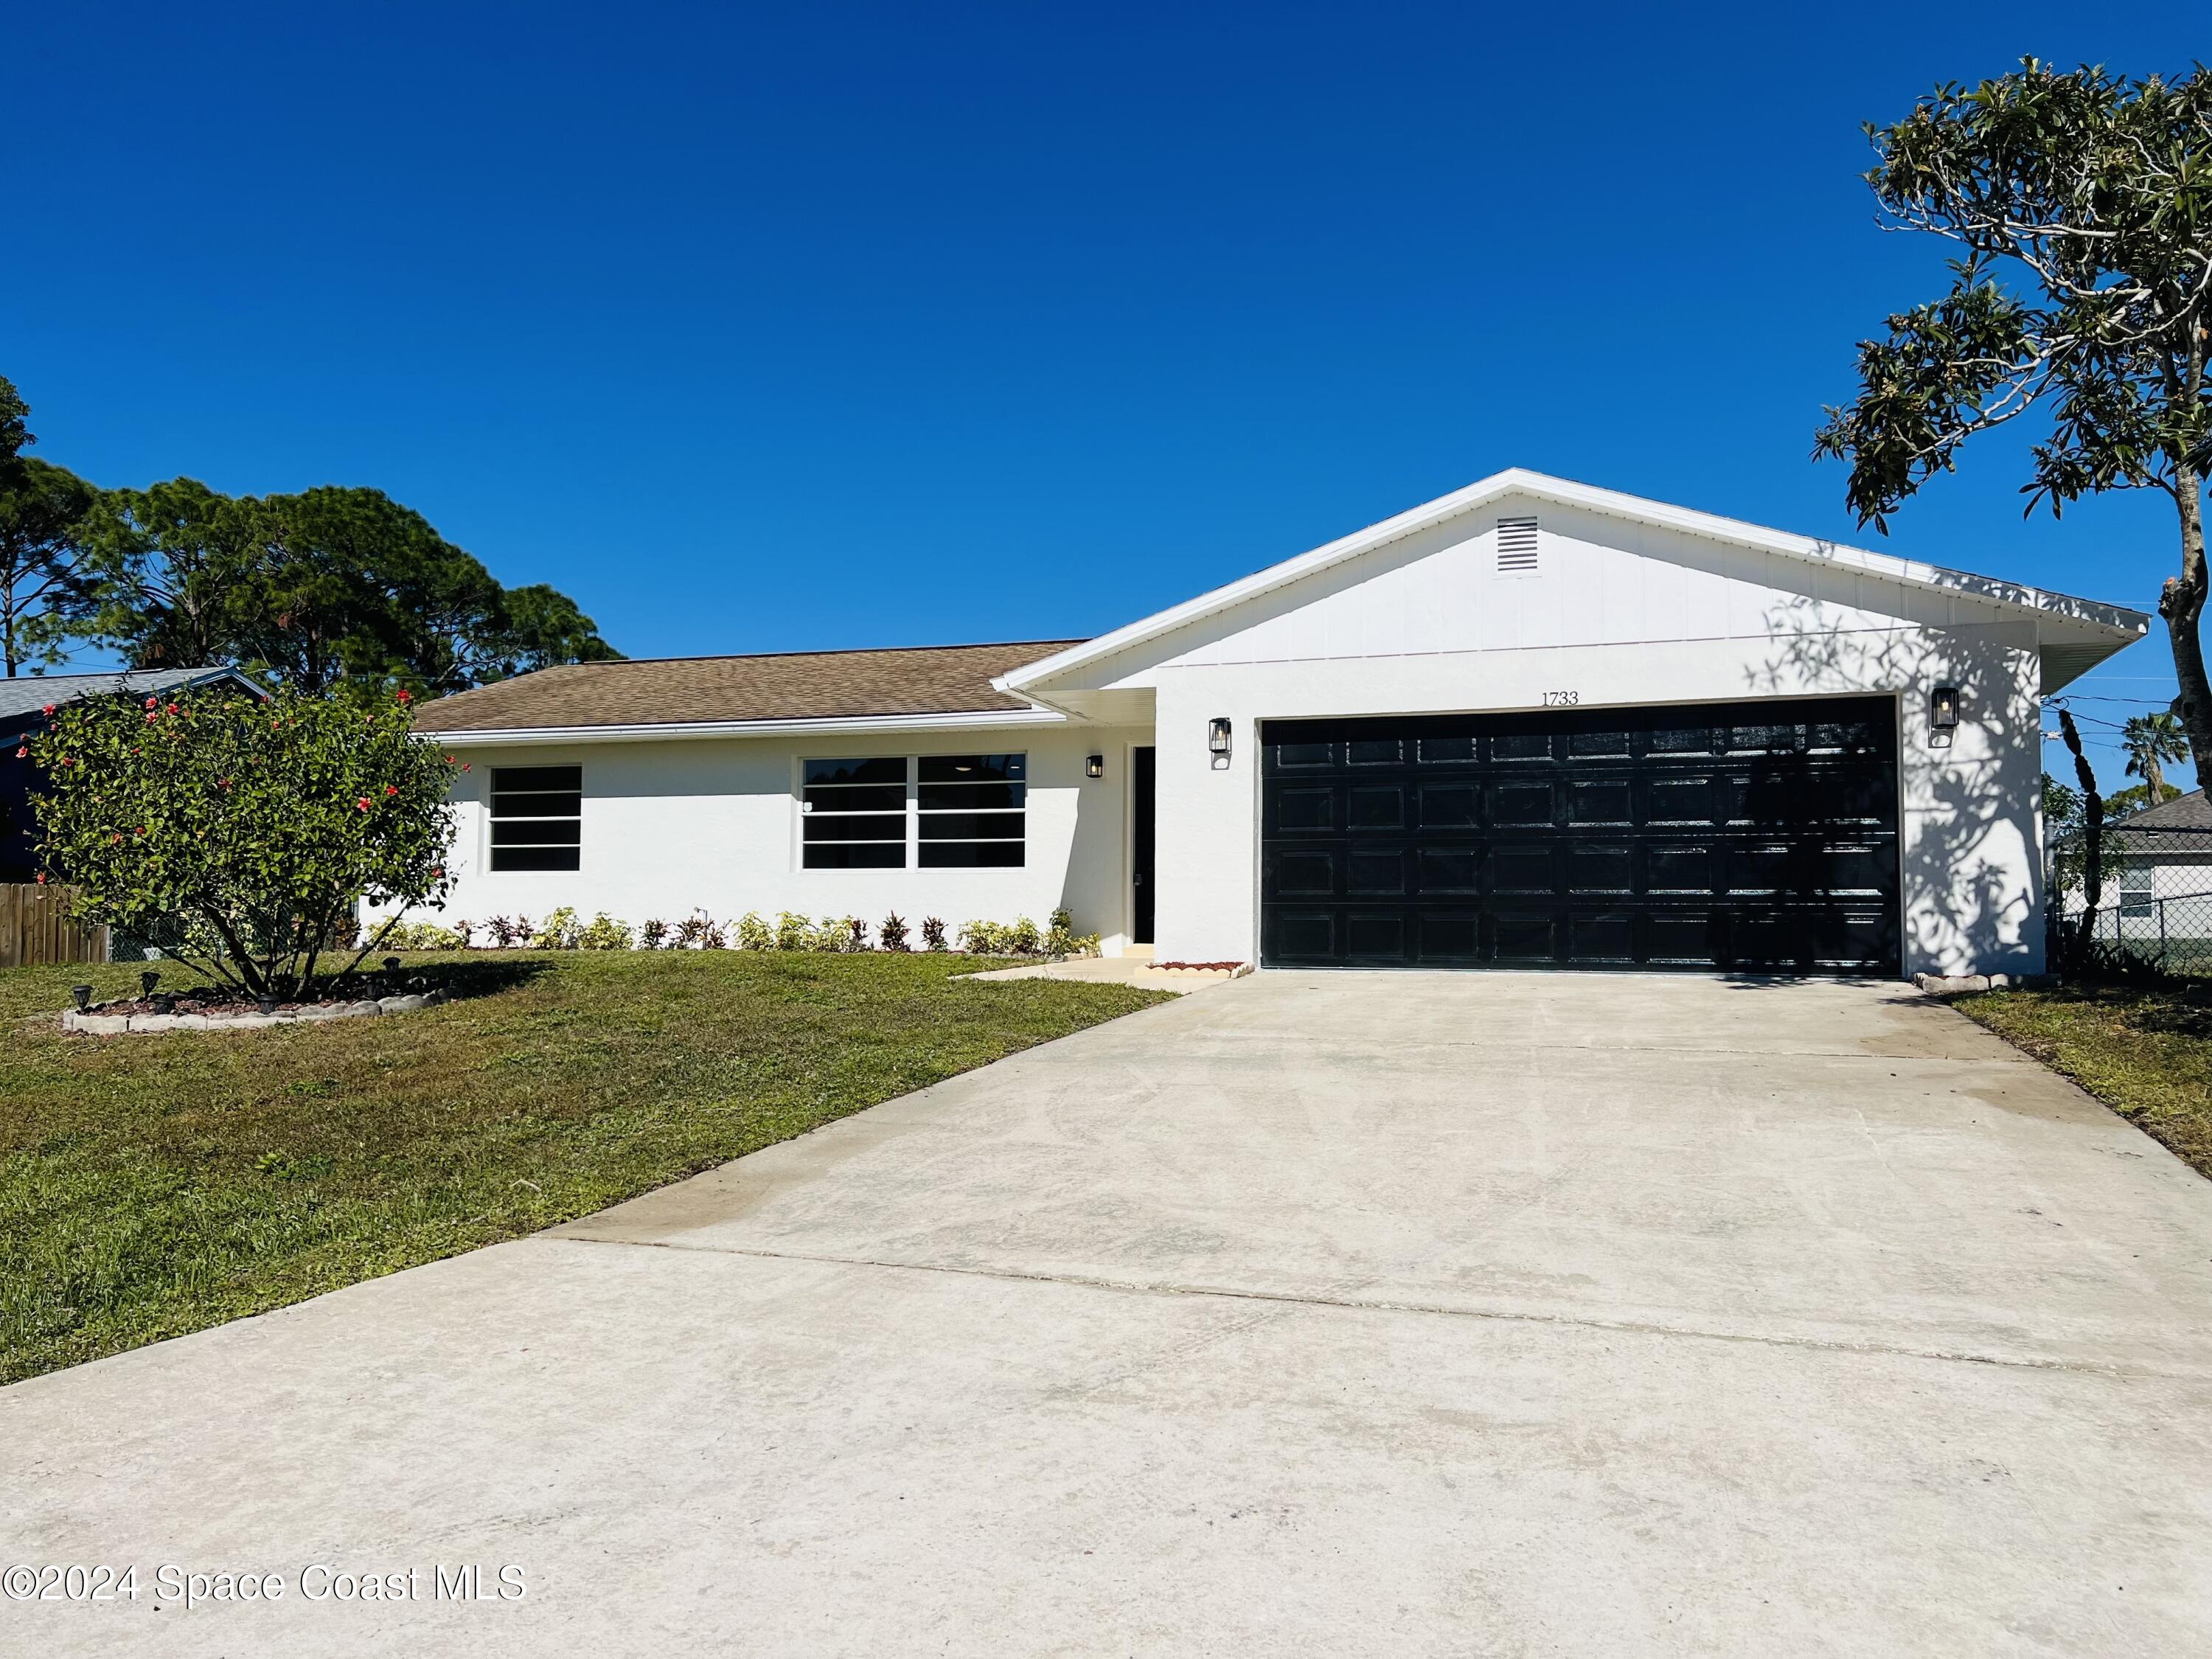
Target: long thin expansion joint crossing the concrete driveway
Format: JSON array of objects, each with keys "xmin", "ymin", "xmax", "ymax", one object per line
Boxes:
[{"xmin": 535, "ymin": 1230, "xmax": 2177, "ymax": 1382}]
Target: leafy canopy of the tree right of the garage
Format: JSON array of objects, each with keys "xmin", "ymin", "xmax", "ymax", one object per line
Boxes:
[{"xmin": 1816, "ymin": 58, "xmax": 2212, "ymax": 776}]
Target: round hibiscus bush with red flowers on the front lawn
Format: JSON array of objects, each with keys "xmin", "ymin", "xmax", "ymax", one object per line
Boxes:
[{"xmin": 31, "ymin": 686, "xmax": 456, "ymax": 995}]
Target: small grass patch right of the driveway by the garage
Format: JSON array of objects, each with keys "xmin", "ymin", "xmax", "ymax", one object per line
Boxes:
[{"xmin": 1953, "ymin": 982, "xmax": 2212, "ymax": 1177}]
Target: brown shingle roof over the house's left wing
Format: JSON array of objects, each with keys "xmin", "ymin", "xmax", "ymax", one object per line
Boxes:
[{"xmin": 416, "ymin": 639, "xmax": 1077, "ymax": 732}]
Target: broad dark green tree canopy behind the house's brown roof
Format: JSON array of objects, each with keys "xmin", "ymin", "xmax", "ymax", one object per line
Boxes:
[{"xmin": 86, "ymin": 478, "xmax": 622, "ymax": 695}]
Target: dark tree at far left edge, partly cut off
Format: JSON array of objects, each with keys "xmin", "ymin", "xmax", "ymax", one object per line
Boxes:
[{"xmin": 0, "ymin": 376, "xmax": 93, "ymax": 679}]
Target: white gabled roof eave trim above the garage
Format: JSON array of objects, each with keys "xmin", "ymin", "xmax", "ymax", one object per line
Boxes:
[{"xmin": 1013, "ymin": 467, "xmax": 2150, "ymax": 701}]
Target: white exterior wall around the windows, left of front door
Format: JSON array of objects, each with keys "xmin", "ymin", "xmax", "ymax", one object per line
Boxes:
[{"xmin": 418, "ymin": 726, "xmax": 1148, "ymax": 949}]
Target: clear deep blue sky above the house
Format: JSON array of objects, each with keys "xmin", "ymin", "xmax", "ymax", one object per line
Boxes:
[{"xmin": 0, "ymin": 0, "xmax": 2203, "ymax": 781}]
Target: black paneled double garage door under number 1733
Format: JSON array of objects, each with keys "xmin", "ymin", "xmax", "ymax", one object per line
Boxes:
[{"xmin": 1261, "ymin": 697, "xmax": 1898, "ymax": 973}]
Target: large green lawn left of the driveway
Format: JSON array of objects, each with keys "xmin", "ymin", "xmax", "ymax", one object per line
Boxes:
[{"xmin": 0, "ymin": 951, "xmax": 1166, "ymax": 1382}]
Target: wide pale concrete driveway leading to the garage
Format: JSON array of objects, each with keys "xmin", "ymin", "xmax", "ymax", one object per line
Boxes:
[{"xmin": 0, "ymin": 973, "xmax": 2212, "ymax": 1655}]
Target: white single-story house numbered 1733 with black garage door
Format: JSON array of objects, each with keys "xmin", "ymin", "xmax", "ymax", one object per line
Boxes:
[{"xmin": 420, "ymin": 471, "xmax": 2148, "ymax": 973}]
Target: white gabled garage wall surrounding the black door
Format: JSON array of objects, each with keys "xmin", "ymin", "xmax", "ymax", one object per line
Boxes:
[{"xmin": 1086, "ymin": 502, "xmax": 2044, "ymax": 973}]
